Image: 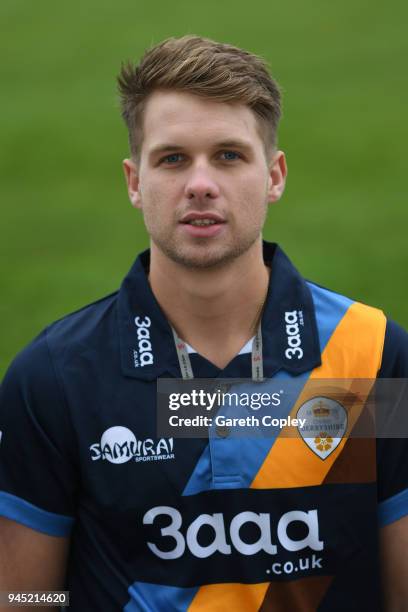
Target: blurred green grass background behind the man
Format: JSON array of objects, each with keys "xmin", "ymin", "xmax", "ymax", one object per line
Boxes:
[{"xmin": 0, "ymin": 0, "xmax": 408, "ymax": 377}]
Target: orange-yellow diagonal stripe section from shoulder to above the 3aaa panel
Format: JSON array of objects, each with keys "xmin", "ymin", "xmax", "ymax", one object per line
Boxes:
[{"xmin": 251, "ymin": 303, "xmax": 386, "ymax": 489}]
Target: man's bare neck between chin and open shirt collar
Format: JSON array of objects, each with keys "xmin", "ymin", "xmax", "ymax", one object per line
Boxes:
[{"xmin": 149, "ymin": 240, "xmax": 269, "ymax": 367}]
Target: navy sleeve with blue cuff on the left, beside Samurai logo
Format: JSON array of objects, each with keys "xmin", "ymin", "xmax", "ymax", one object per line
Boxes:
[{"xmin": 0, "ymin": 332, "xmax": 78, "ymax": 536}]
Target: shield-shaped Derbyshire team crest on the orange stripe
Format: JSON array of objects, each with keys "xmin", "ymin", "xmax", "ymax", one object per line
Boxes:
[{"xmin": 296, "ymin": 397, "xmax": 347, "ymax": 461}]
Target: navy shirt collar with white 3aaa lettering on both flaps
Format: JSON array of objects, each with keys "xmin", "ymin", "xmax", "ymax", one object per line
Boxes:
[{"xmin": 118, "ymin": 241, "xmax": 321, "ymax": 381}]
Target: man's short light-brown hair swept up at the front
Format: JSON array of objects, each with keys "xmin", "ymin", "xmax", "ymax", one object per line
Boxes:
[{"xmin": 118, "ymin": 36, "xmax": 281, "ymax": 158}]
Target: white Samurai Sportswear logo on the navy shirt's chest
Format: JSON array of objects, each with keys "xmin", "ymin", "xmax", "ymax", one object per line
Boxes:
[{"xmin": 89, "ymin": 425, "xmax": 174, "ymax": 463}]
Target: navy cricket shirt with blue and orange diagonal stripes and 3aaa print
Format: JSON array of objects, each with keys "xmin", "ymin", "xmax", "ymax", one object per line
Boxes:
[{"xmin": 0, "ymin": 242, "xmax": 408, "ymax": 612}]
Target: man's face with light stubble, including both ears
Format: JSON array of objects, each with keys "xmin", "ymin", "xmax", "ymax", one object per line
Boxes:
[{"xmin": 124, "ymin": 91, "xmax": 286, "ymax": 268}]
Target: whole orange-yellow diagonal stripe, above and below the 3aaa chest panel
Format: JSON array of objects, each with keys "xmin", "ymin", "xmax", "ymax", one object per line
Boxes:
[{"xmin": 188, "ymin": 303, "xmax": 385, "ymax": 612}]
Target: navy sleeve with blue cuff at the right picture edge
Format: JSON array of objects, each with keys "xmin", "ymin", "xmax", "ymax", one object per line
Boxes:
[{"xmin": 377, "ymin": 321, "xmax": 408, "ymax": 527}]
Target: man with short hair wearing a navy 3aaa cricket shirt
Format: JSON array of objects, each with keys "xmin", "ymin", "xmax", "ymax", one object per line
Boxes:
[{"xmin": 0, "ymin": 37, "xmax": 408, "ymax": 612}]
